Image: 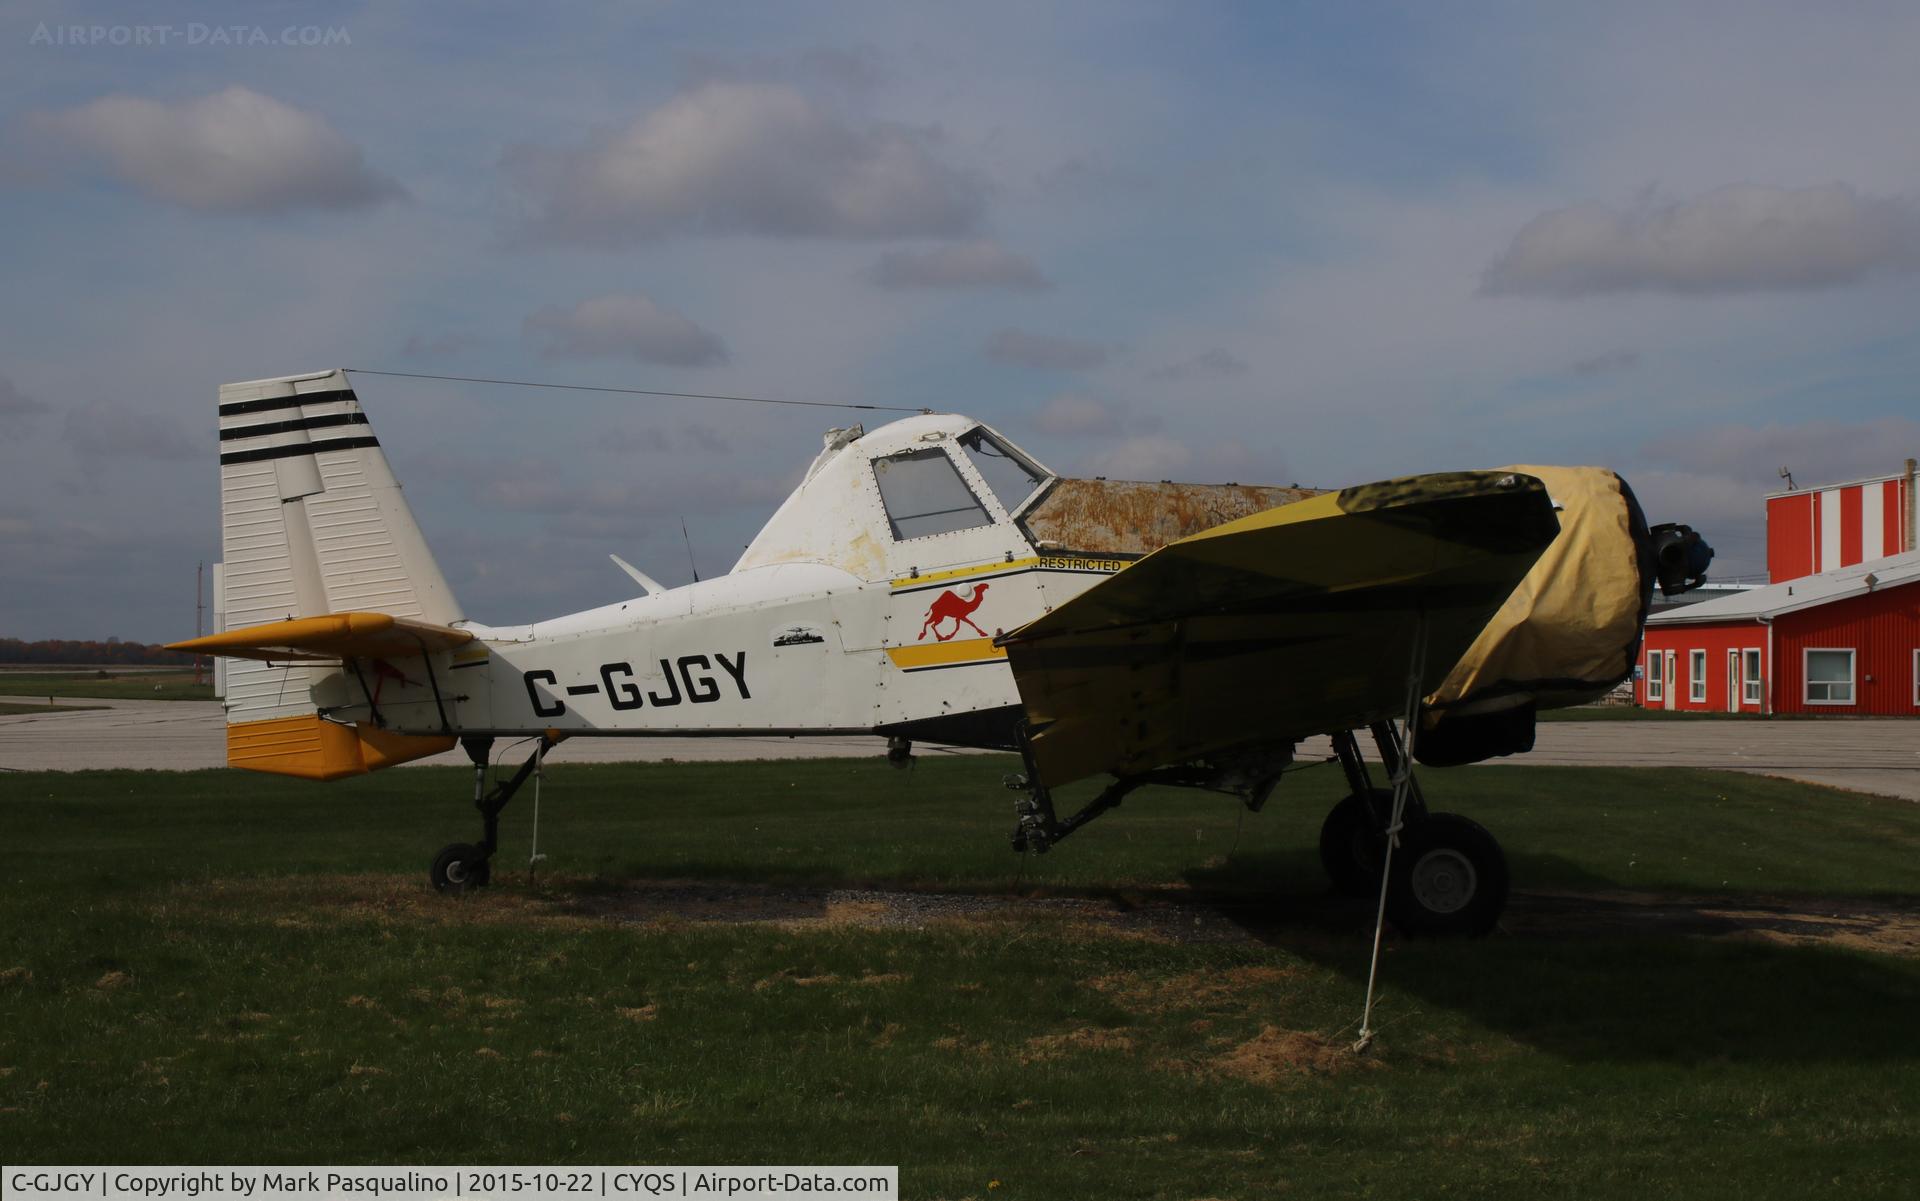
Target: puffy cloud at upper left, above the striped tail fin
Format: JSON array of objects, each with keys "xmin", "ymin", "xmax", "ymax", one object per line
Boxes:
[{"xmin": 27, "ymin": 86, "xmax": 403, "ymax": 213}]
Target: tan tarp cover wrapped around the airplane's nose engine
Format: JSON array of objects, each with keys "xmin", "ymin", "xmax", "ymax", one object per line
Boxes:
[{"xmin": 1427, "ymin": 466, "xmax": 1647, "ymax": 714}]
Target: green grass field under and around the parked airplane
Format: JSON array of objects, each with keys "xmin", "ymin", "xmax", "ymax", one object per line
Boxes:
[{"xmin": 0, "ymin": 758, "xmax": 1920, "ymax": 1199}]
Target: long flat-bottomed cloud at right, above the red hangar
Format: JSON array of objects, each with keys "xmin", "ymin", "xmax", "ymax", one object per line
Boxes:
[{"xmin": 1480, "ymin": 184, "xmax": 1920, "ymax": 297}]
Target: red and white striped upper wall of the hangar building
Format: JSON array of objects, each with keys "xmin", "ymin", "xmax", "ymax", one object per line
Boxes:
[{"xmin": 1766, "ymin": 476, "xmax": 1912, "ymax": 583}]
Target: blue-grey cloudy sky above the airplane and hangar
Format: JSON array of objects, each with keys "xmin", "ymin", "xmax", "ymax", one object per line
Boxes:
[{"xmin": 0, "ymin": 0, "xmax": 1920, "ymax": 641}]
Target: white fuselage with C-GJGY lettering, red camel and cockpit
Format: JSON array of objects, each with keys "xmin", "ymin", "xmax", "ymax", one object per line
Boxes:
[{"xmin": 332, "ymin": 416, "xmax": 1123, "ymax": 741}]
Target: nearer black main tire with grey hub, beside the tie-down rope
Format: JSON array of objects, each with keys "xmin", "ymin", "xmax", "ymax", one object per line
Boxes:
[{"xmin": 1386, "ymin": 813, "xmax": 1509, "ymax": 938}]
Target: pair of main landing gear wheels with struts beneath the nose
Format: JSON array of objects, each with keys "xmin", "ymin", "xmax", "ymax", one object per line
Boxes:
[{"xmin": 1319, "ymin": 721, "xmax": 1509, "ymax": 936}]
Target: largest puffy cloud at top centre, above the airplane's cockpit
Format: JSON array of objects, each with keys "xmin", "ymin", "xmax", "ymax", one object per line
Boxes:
[{"xmin": 503, "ymin": 81, "xmax": 985, "ymax": 246}]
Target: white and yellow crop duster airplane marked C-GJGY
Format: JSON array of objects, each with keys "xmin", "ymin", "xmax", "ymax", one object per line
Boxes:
[{"xmin": 175, "ymin": 370, "xmax": 1713, "ymax": 932}]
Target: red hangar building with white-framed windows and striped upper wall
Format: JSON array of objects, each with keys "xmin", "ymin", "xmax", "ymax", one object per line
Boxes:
[{"xmin": 1634, "ymin": 459, "xmax": 1920, "ymax": 718}]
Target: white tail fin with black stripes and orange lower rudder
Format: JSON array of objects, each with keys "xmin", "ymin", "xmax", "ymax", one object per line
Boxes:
[{"xmin": 192, "ymin": 370, "xmax": 463, "ymax": 779}]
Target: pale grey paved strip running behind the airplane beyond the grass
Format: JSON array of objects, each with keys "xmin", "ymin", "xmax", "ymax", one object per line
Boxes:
[{"xmin": 0, "ymin": 696, "xmax": 1920, "ymax": 802}]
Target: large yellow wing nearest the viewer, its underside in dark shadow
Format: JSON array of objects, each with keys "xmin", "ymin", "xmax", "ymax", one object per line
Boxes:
[{"xmin": 1002, "ymin": 472, "xmax": 1559, "ymax": 787}]
